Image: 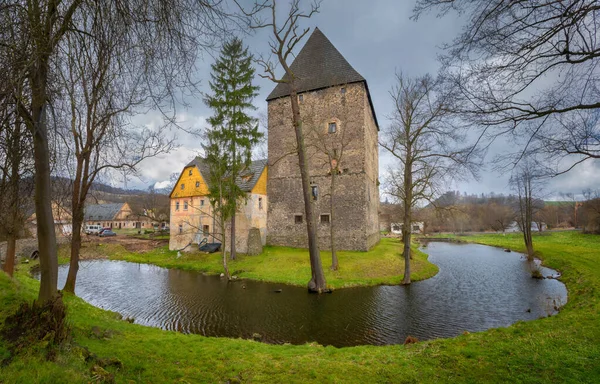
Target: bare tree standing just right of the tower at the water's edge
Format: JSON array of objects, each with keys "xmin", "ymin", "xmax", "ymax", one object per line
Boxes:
[{"xmin": 380, "ymin": 74, "xmax": 473, "ymax": 284}]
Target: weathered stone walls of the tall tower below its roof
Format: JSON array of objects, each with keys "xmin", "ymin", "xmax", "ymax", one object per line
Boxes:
[{"xmin": 267, "ymin": 83, "xmax": 379, "ymax": 251}]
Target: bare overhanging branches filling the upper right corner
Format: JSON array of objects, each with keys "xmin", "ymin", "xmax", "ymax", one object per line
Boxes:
[{"xmin": 413, "ymin": 0, "xmax": 600, "ymax": 174}]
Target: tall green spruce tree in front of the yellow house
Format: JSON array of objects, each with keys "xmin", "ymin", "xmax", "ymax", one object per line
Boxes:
[{"xmin": 204, "ymin": 38, "xmax": 262, "ymax": 260}]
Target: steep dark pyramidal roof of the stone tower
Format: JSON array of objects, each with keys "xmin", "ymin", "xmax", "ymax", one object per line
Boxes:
[{"xmin": 267, "ymin": 28, "xmax": 379, "ymax": 130}]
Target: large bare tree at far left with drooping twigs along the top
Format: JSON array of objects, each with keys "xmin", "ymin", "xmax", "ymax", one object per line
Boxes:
[{"xmin": 0, "ymin": 0, "xmax": 231, "ymax": 302}]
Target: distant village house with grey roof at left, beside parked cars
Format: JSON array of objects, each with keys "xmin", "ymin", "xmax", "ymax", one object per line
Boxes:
[{"xmin": 84, "ymin": 203, "xmax": 155, "ymax": 229}]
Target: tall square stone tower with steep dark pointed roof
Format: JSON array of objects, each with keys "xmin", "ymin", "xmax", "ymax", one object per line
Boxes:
[{"xmin": 267, "ymin": 28, "xmax": 379, "ymax": 251}]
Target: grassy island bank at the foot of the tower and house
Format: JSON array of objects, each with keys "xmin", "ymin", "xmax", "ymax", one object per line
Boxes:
[{"xmin": 107, "ymin": 238, "xmax": 438, "ymax": 289}]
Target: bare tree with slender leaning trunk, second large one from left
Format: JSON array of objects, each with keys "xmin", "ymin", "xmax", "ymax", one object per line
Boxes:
[{"xmin": 55, "ymin": 12, "xmax": 173, "ymax": 293}]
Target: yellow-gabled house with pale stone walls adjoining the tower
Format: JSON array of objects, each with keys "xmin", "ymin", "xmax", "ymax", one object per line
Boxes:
[{"xmin": 169, "ymin": 157, "xmax": 267, "ymax": 253}]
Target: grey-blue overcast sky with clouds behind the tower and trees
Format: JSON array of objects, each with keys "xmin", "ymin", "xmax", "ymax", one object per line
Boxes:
[{"xmin": 124, "ymin": 0, "xmax": 600, "ymax": 201}]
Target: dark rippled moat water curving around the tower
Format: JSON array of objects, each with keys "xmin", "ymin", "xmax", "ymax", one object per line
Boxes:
[{"xmin": 47, "ymin": 242, "xmax": 567, "ymax": 347}]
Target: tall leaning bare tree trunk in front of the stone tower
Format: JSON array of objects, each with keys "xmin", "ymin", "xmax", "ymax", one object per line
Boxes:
[{"xmin": 290, "ymin": 91, "xmax": 328, "ymax": 293}]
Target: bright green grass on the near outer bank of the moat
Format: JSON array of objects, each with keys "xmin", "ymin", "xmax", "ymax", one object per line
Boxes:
[{"xmin": 0, "ymin": 233, "xmax": 600, "ymax": 384}]
